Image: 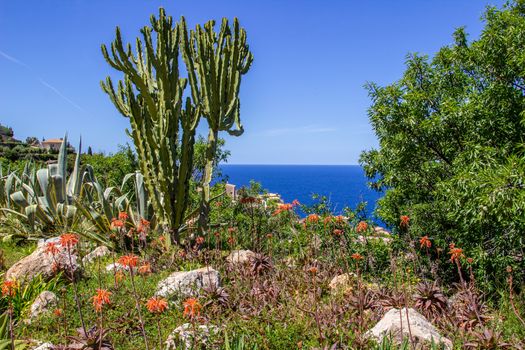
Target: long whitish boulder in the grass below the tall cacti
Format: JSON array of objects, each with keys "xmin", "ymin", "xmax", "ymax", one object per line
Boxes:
[{"xmin": 155, "ymin": 267, "xmax": 220, "ymax": 298}]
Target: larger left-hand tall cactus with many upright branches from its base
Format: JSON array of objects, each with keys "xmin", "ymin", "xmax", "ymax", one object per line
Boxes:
[{"xmin": 101, "ymin": 8, "xmax": 200, "ymax": 242}]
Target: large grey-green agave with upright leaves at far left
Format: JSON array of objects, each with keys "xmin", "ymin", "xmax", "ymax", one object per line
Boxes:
[{"xmin": 3, "ymin": 136, "xmax": 93, "ymax": 235}]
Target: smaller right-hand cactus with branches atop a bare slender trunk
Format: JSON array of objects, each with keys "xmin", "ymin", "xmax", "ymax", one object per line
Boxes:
[{"xmin": 181, "ymin": 18, "xmax": 253, "ymax": 231}]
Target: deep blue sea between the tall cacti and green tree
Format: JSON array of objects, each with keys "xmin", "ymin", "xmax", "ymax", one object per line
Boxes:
[{"xmin": 221, "ymin": 164, "xmax": 381, "ymax": 221}]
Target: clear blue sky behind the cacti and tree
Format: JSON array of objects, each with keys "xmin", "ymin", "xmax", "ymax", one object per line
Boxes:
[{"xmin": 0, "ymin": 0, "xmax": 502, "ymax": 164}]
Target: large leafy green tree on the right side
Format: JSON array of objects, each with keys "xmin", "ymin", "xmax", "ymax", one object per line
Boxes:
[{"xmin": 361, "ymin": 0, "xmax": 525, "ymax": 286}]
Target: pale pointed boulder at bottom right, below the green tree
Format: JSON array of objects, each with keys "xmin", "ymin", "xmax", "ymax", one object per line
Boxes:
[{"xmin": 366, "ymin": 308, "xmax": 452, "ymax": 349}]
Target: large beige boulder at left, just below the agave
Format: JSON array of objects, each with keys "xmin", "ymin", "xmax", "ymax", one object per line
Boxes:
[{"xmin": 5, "ymin": 238, "xmax": 80, "ymax": 282}]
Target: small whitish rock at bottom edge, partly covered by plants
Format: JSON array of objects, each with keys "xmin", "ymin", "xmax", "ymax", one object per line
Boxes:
[{"xmin": 166, "ymin": 323, "xmax": 219, "ymax": 350}]
